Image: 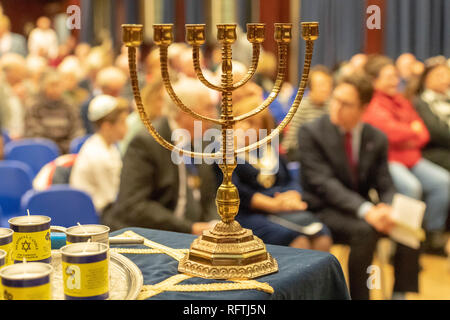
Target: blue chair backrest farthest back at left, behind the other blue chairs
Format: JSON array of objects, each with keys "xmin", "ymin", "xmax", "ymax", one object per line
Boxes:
[{"xmin": 5, "ymin": 138, "xmax": 60, "ymax": 176}]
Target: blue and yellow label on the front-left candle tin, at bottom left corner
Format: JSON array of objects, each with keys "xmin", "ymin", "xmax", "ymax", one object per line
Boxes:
[{"xmin": 1, "ymin": 276, "xmax": 52, "ymax": 300}]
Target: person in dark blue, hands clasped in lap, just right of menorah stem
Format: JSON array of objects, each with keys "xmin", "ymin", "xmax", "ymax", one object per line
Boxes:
[{"xmin": 227, "ymin": 95, "xmax": 332, "ymax": 251}]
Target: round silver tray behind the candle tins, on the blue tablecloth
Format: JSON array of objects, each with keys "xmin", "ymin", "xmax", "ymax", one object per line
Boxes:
[{"xmin": 51, "ymin": 250, "xmax": 144, "ymax": 300}]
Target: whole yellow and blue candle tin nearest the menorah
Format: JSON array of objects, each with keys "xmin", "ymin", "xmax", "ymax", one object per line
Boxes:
[{"xmin": 60, "ymin": 242, "xmax": 109, "ymax": 300}]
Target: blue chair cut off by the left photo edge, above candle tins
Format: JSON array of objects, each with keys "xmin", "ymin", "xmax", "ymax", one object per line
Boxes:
[{"xmin": 0, "ymin": 160, "xmax": 33, "ymax": 227}]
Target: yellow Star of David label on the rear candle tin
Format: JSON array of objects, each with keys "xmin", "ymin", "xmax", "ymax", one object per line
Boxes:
[{"xmin": 12, "ymin": 229, "xmax": 52, "ymax": 262}]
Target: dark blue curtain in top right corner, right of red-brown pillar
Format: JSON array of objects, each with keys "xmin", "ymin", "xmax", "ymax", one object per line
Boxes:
[{"xmin": 385, "ymin": 0, "xmax": 450, "ymax": 60}]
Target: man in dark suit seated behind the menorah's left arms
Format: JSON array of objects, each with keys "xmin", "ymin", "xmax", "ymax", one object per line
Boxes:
[{"xmin": 102, "ymin": 79, "xmax": 219, "ymax": 235}]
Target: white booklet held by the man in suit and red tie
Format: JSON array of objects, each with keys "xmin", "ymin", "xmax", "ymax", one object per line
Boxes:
[{"xmin": 389, "ymin": 193, "xmax": 426, "ymax": 249}]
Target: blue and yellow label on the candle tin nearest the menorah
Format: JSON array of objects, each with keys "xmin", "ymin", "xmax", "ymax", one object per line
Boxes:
[{"xmin": 62, "ymin": 253, "xmax": 109, "ymax": 299}]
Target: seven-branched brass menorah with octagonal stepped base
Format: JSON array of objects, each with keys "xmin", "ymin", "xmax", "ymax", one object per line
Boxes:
[{"xmin": 122, "ymin": 22, "xmax": 319, "ymax": 279}]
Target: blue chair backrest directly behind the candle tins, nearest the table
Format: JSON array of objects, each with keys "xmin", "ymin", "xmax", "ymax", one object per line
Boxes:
[{"xmin": 22, "ymin": 185, "xmax": 100, "ymax": 228}]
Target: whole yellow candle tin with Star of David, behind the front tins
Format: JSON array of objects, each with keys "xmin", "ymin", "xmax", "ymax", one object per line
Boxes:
[{"xmin": 8, "ymin": 215, "xmax": 52, "ymax": 263}]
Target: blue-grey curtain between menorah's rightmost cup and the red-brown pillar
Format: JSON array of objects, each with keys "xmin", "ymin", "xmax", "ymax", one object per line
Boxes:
[{"xmin": 299, "ymin": 0, "xmax": 366, "ymax": 69}]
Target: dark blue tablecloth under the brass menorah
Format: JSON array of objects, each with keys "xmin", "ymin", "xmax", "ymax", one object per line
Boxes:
[{"xmin": 111, "ymin": 228, "xmax": 350, "ymax": 300}]
